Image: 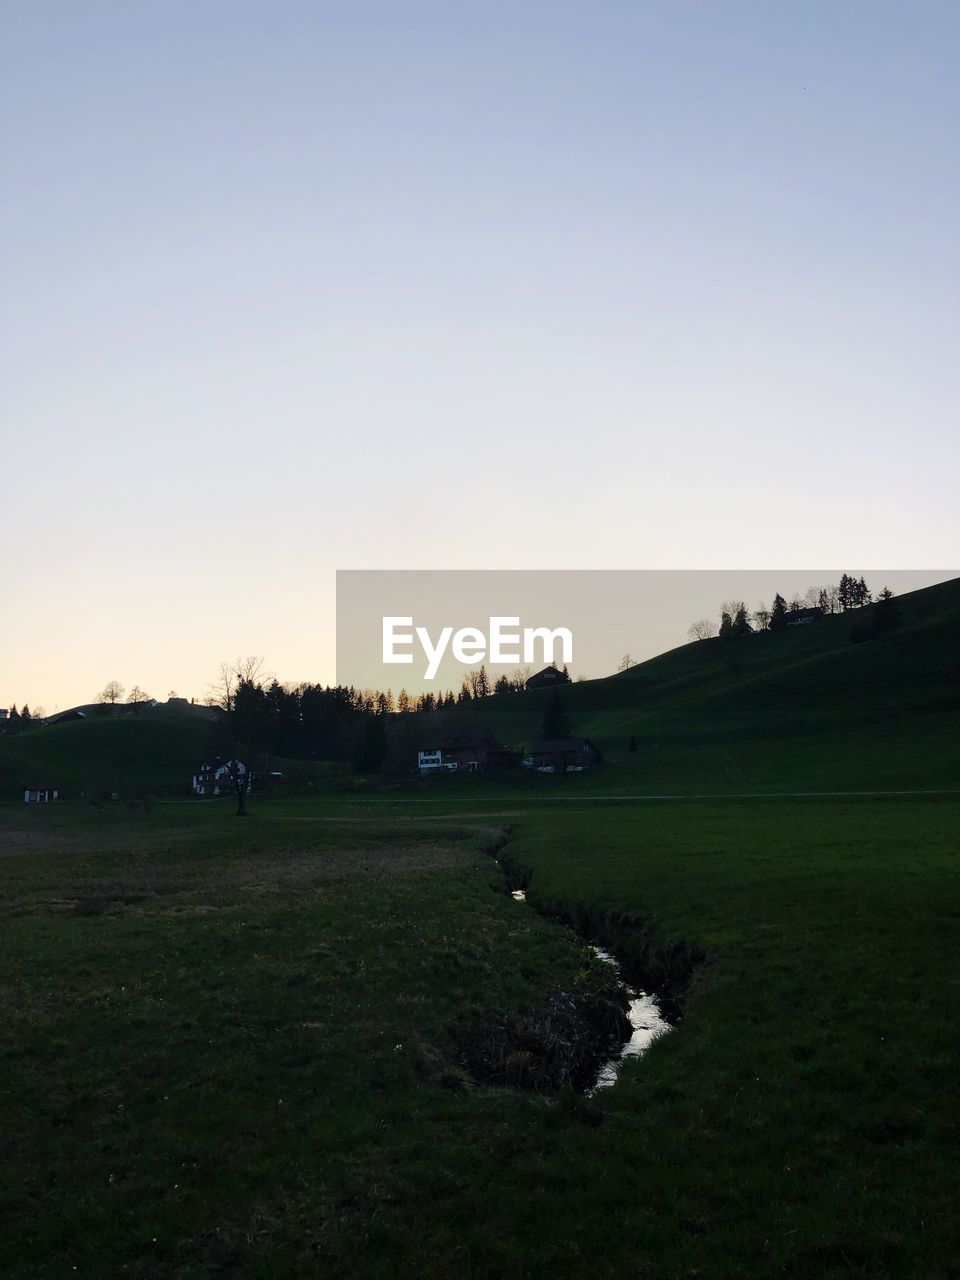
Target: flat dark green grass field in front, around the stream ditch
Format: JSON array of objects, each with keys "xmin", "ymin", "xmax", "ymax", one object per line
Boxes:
[{"xmin": 0, "ymin": 790, "xmax": 960, "ymax": 1280}]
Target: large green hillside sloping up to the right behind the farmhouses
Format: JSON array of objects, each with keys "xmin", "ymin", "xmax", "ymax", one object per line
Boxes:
[{"xmin": 431, "ymin": 579, "xmax": 960, "ymax": 790}]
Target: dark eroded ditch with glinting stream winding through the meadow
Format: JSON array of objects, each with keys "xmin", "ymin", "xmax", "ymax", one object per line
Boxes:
[{"xmin": 470, "ymin": 829, "xmax": 705, "ymax": 1094}]
